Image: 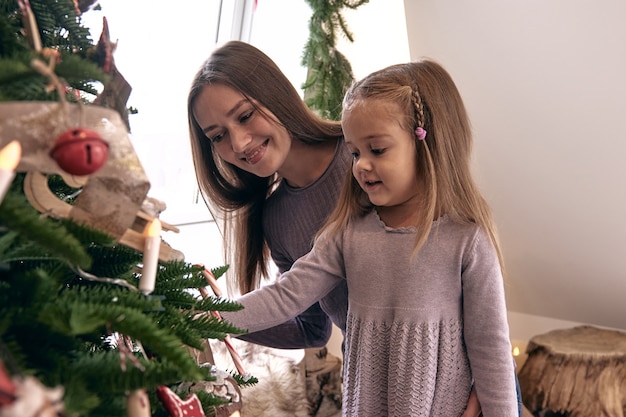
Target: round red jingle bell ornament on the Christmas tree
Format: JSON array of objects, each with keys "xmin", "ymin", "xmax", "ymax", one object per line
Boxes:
[{"xmin": 50, "ymin": 127, "xmax": 109, "ymax": 176}]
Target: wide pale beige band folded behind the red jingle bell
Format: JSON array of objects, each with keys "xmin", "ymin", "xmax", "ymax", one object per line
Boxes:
[{"xmin": 0, "ymin": 101, "xmax": 150, "ymax": 238}]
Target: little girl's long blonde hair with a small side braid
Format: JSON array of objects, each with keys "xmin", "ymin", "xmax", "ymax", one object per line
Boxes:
[{"xmin": 318, "ymin": 59, "xmax": 504, "ymax": 270}]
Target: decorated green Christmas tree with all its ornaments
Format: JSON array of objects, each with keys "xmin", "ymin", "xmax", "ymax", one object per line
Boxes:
[{"xmin": 0, "ymin": 0, "xmax": 256, "ymax": 417}]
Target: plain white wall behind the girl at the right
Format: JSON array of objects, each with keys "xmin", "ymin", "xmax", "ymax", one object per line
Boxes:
[{"xmin": 405, "ymin": 0, "xmax": 626, "ymax": 335}]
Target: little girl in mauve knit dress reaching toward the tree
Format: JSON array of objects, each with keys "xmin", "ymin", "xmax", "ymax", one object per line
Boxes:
[{"xmin": 219, "ymin": 60, "xmax": 519, "ymax": 417}]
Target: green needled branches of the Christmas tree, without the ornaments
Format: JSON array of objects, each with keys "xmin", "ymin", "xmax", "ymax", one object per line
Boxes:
[{"xmin": 0, "ymin": 0, "xmax": 257, "ymax": 417}]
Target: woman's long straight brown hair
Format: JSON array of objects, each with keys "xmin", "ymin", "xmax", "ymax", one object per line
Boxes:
[{"xmin": 187, "ymin": 41, "xmax": 342, "ymax": 294}]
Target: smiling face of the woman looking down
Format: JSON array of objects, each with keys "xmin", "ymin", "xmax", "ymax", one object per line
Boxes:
[{"xmin": 193, "ymin": 84, "xmax": 291, "ymax": 177}]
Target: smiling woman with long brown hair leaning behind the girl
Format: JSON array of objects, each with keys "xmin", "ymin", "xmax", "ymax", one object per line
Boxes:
[{"xmin": 187, "ymin": 41, "xmax": 480, "ymax": 417}]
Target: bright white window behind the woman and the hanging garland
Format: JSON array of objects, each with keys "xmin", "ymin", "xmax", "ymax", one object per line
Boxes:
[{"xmin": 83, "ymin": 0, "xmax": 409, "ymax": 294}]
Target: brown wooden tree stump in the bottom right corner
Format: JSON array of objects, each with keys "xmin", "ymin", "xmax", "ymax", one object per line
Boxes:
[{"xmin": 518, "ymin": 326, "xmax": 626, "ymax": 417}]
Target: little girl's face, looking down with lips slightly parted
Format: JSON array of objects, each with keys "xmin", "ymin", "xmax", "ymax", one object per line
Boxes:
[{"xmin": 341, "ymin": 99, "xmax": 418, "ymax": 220}]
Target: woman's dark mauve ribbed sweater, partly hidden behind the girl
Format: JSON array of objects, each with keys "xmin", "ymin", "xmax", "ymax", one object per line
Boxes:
[{"xmin": 229, "ymin": 140, "xmax": 350, "ymax": 349}]
